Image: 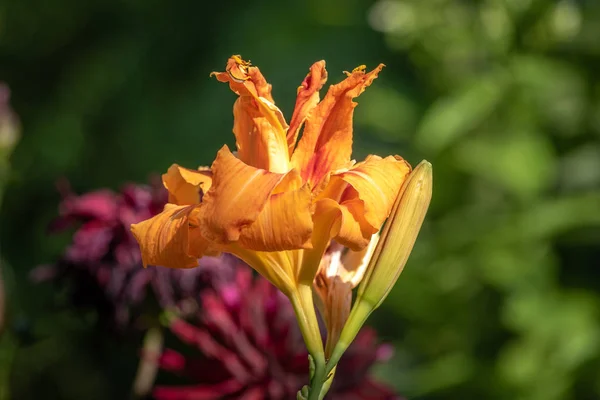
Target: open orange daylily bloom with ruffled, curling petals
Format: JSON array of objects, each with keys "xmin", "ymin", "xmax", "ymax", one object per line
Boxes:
[{"xmin": 132, "ymin": 56, "xmax": 411, "ymax": 294}]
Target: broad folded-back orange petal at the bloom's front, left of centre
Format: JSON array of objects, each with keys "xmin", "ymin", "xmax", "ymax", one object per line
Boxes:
[{"xmin": 199, "ymin": 146, "xmax": 294, "ymax": 244}]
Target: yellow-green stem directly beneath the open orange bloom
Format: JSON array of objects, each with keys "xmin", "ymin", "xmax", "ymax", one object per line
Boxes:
[{"xmin": 290, "ymin": 284, "xmax": 327, "ymax": 400}]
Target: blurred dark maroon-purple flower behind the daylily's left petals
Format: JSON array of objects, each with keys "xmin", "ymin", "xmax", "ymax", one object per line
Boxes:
[{"xmin": 31, "ymin": 180, "xmax": 221, "ymax": 328}]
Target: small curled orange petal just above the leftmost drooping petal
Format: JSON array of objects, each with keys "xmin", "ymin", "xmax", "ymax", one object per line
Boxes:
[{"xmin": 162, "ymin": 164, "xmax": 212, "ymax": 205}]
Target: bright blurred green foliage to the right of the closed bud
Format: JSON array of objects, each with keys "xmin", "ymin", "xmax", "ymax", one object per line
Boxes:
[{"xmin": 369, "ymin": 0, "xmax": 600, "ymax": 400}]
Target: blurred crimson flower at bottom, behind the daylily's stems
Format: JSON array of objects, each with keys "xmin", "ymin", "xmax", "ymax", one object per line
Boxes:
[{"xmin": 153, "ymin": 266, "xmax": 399, "ymax": 400}]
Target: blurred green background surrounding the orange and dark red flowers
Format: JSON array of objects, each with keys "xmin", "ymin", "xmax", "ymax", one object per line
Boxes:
[{"xmin": 0, "ymin": 0, "xmax": 600, "ymax": 400}]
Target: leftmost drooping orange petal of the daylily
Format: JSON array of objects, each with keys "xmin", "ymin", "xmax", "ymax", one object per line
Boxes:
[{"xmin": 131, "ymin": 204, "xmax": 207, "ymax": 268}]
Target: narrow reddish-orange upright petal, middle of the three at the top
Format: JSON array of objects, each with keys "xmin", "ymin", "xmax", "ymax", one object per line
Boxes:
[{"xmin": 287, "ymin": 60, "xmax": 327, "ymax": 154}]
